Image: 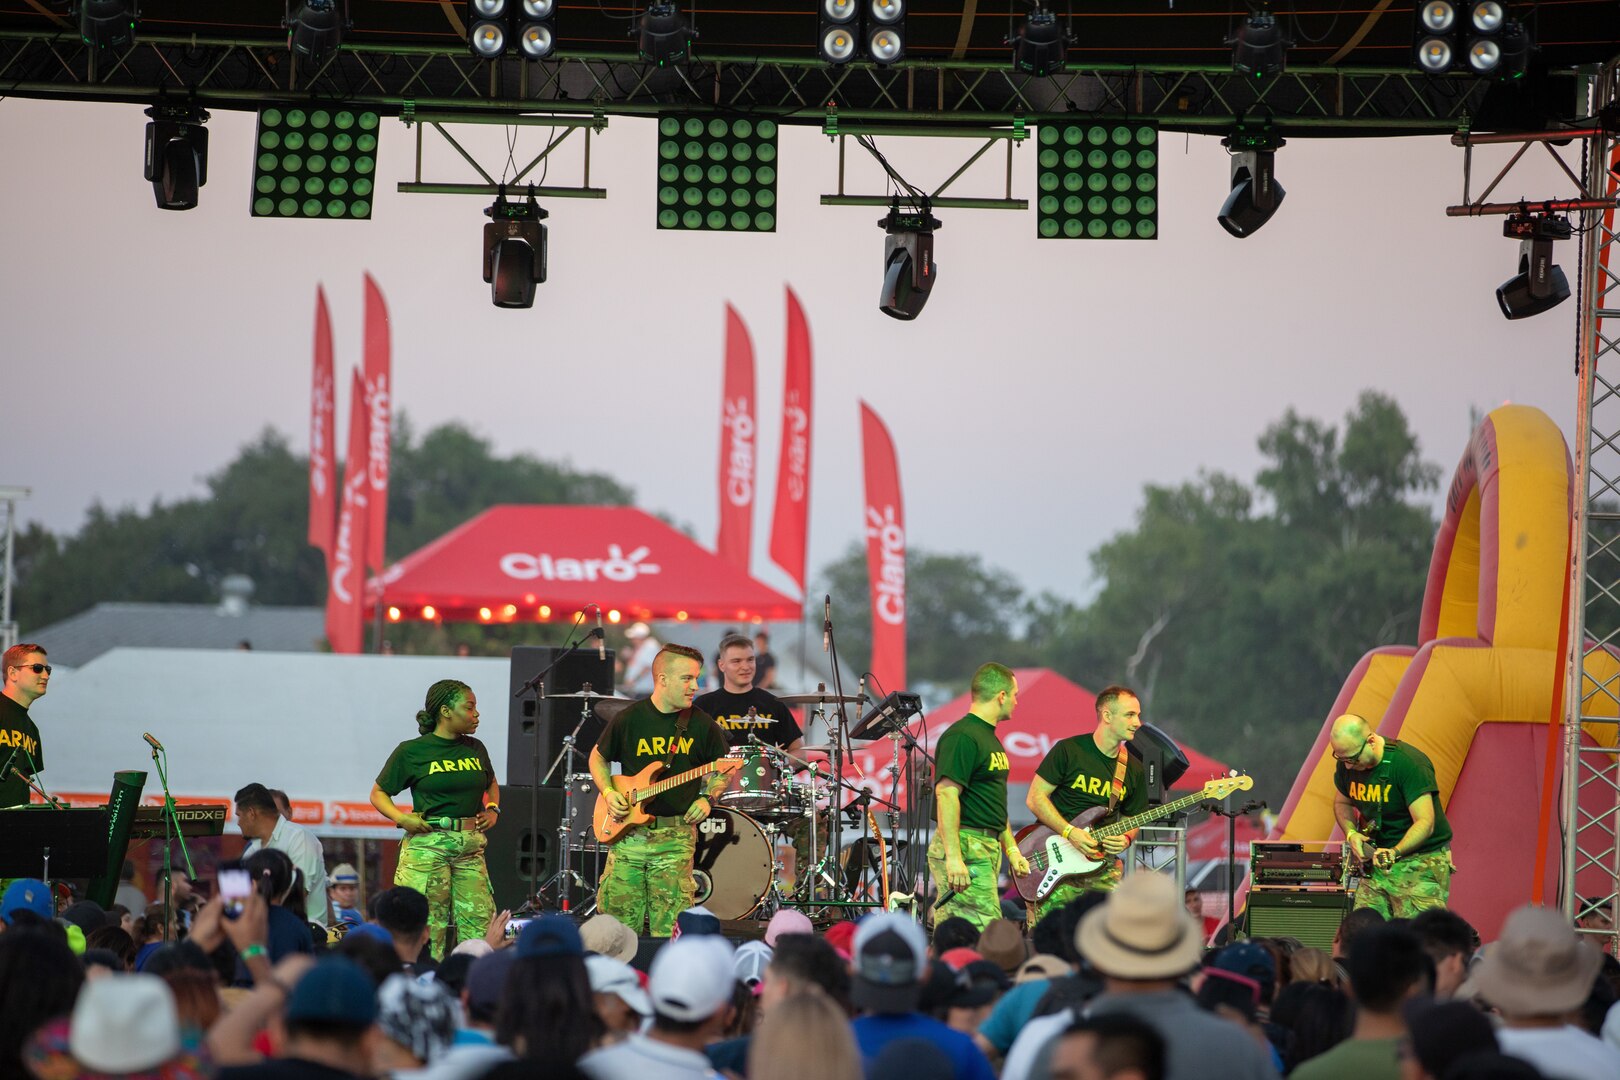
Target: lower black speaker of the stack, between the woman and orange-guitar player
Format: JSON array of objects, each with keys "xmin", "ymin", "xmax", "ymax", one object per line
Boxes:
[{"xmin": 484, "ymin": 784, "xmax": 608, "ymax": 912}]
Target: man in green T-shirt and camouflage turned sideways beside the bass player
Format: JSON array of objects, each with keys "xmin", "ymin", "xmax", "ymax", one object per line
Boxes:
[{"xmin": 928, "ymin": 664, "xmax": 1029, "ymax": 929}]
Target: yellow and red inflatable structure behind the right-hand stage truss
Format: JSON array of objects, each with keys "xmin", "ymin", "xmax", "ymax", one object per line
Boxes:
[{"xmin": 1272, "ymin": 405, "xmax": 1617, "ymax": 941}]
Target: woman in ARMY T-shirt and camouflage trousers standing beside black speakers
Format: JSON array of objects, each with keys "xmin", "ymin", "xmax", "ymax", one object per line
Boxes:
[{"xmin": 371, "ymin": 678, "xmax": 501, "ymax": 960}]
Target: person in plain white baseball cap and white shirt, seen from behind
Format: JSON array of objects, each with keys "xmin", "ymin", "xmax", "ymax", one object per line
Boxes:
[{"xmin": 578, "ymin": 932, "xmax": 734, "ymax": 1080}]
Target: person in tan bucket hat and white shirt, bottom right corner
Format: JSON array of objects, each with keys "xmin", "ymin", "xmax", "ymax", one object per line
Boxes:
[{"xmin": 1474, "ymin": 905, "xmax": 1620, "ymax": 1080}]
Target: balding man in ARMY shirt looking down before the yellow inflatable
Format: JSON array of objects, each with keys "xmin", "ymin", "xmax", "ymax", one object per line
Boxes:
[{"xmin": 1328, "ymin": 712, "xmax": 1452, "ymax": 918}]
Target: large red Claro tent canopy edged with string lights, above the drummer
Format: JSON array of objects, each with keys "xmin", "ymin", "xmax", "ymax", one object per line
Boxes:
[{"xmin": 368, "ymin": 505, "xmax": 800, "ymax": 622}]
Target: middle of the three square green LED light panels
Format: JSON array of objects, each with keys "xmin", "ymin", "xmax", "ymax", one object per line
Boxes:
[{"xmin": 658, "ymin": 115, "xmax": 776, "ymax": 233}]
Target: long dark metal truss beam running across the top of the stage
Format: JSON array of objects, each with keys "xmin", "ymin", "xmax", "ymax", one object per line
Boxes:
[{"xmin": 0, "ymin": 31, "xmax": 1487, "ymax": 134}]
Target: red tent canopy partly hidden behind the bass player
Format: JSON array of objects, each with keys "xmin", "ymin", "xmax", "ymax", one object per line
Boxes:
[{"xmin": 857, "ymin": 667, "xmax": 1228, "ymax": 792}]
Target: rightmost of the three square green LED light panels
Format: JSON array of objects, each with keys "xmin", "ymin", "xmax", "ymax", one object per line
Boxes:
[{"xmin": 1035, "ymin": 123, "xmax": 1158, "ymax": 240}]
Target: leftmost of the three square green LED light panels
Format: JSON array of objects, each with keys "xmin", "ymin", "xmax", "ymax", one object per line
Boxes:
[{"xmin": 253, "ymin": 105, "xmax": 377, "ymax": 220}]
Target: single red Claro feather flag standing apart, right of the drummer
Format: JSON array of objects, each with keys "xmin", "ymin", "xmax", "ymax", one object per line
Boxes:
[{"xmin": 860, "ymin": 402, "xmax": 906, "ymax": 693}]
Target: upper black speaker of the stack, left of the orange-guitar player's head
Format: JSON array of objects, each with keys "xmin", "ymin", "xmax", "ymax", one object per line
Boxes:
[{"xmin": 502, "ymin": 644, "xmax": 612, "ymax": 786}]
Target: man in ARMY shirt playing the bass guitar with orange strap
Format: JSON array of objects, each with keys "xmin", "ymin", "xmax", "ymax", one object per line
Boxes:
[{"xmin": 1024, "ymin": 687, "xmax": 1147, "ymax": 920}]
